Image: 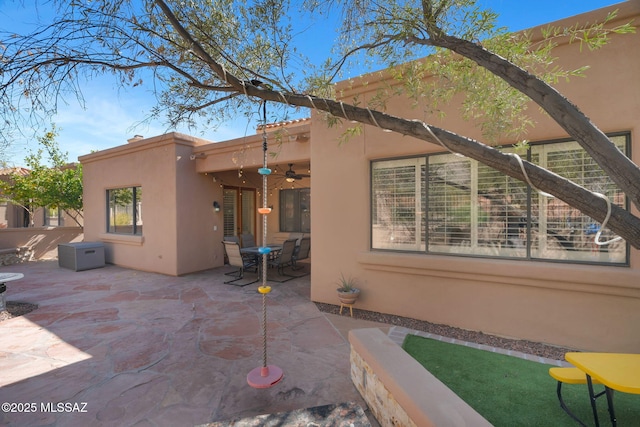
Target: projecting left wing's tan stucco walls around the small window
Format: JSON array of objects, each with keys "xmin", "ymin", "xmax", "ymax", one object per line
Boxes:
[{"xmin": 80, "ymin": 133, "xmax": 223, "ymax": 275}]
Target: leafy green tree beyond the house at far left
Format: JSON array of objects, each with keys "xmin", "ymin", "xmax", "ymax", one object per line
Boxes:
[{"xmin": 0, "ymin": 126, "xmax": 82, "ymax": 227}]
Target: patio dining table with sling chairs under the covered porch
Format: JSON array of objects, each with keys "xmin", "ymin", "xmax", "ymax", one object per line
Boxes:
[{"xmin": 222, "ymin": 235, "xmax": 311, "ymax": 286}]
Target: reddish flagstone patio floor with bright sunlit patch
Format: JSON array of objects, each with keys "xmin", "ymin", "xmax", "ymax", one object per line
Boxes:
[{"xmin": 0, "ymin": 261, "xmax": 388, "ymax": 426}]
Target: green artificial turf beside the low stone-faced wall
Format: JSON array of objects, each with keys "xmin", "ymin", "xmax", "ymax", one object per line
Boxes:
[{"xmin": 402, "ymin": 335, "xmax": 640, "ymax": 427}]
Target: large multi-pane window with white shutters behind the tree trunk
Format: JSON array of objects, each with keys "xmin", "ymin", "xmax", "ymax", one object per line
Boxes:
[{"xmin": 371, "ymin": 135, "xmax": 628, "ymax": 264}]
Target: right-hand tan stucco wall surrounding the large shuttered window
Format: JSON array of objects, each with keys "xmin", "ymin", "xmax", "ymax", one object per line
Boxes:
[{"xmin": 311, "ymin": 1, "xmax": 640, "ymax": 352}]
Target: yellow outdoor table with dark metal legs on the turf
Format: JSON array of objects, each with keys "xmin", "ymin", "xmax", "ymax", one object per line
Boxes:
[{"xmin": 565, "ymin": 353, "xmax": 640, "ymax": 427}]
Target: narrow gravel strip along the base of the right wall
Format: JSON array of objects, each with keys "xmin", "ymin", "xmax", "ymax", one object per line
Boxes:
[{"xmin": 316, "ymin": 303, "xmax": 576, "ymax": 360}]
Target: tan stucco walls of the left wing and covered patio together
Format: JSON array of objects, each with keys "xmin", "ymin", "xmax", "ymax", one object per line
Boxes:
[{"xmin": 80, "ymin": 120, "xmax": 311, "ymax": 275}]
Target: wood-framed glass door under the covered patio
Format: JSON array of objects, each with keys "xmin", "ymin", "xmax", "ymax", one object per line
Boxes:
[{"xmin": 223, "ymin": 187, "xmax": 256, "ymax": 237}]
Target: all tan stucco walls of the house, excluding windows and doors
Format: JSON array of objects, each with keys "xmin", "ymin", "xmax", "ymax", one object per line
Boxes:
[{"xmin": 80, "ymin": 0, "xmax": 640, "ymax": 352}]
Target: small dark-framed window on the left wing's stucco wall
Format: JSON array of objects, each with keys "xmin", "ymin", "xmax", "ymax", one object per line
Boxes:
[{"xmin": 107, "ymin": 187, "xmax": 142, "ymax": 235}]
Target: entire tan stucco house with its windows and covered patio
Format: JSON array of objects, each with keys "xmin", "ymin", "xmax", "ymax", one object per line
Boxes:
[{"xmin": 80, "ymin": 0, "xmax": 640, "ymax": 352}]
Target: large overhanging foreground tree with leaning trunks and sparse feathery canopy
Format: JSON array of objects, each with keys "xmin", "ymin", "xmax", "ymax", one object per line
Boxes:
[{"xmin": 0, "ymin": 0, "xmax": 640, "ymax": 248}]
